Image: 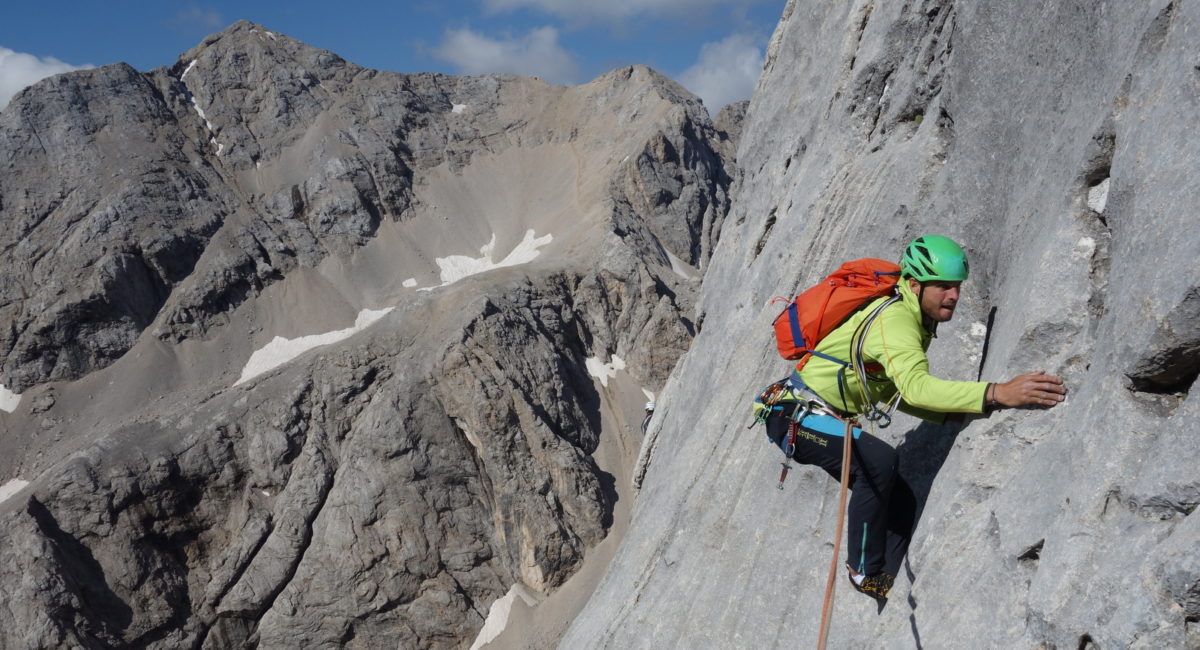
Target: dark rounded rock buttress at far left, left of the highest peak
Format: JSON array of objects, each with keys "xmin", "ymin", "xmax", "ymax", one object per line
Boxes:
[{"xmin": 0, "ymin": 65, "xmax": 230, "ymax": 390}]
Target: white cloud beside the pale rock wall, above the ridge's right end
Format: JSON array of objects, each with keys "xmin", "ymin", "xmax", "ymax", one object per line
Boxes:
[{"xmin": 678, "ymin": 34, "xmax": 763, "ymax": 114}]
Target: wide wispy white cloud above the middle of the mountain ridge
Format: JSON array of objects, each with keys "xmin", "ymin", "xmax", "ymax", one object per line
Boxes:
[{"xmin": 433, "ymin": 26, "xmax": 578, "ymax": 84}]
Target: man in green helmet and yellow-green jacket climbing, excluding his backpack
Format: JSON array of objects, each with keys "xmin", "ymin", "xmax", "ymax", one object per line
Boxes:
[{"xmin": 767, "ymin": 235, "xmax": 1067, "ymax": 604}]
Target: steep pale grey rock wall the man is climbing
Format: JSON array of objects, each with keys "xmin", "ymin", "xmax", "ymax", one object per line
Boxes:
[{"xmin": 562, "ymin": 0, "xmax": 1200, "ymax": 649}]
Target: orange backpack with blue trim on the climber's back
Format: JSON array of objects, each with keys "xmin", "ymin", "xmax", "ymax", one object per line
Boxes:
[{"xmin": 772, "ymin": 258, "xmax": 900, "ymax": 369}]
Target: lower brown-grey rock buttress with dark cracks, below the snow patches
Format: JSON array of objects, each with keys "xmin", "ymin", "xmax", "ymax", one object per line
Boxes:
[{"xmin": 5, "ymin": 291, "xmax": 595, "ymax": 648}]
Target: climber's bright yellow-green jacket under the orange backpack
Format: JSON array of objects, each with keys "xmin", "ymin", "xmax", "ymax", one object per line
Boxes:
[{"xmin": 799, "ymin": 279, "xmax": 988, "ymax": 422}]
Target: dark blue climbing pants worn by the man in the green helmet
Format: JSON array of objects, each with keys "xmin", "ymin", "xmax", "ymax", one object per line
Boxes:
[{"xmin": 767, "ymin": 415, "xmax": 917, "ymax": 576}]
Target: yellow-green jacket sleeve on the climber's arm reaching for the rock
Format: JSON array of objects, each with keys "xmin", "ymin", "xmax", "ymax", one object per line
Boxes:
[{"xmin": 864, "ymin": 305, "xmax": 988, "ymax": 421}]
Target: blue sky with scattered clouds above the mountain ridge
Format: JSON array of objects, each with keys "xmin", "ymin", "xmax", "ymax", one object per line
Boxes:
[{"xmin": 0, "ymin": 0, "xmax": 785, "ymax": 113}]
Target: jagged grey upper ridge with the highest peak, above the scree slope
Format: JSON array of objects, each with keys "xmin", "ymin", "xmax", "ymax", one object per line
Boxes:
[{"xmin": 0, "ymin": 22, "xmax": 728, "ymax": 391}]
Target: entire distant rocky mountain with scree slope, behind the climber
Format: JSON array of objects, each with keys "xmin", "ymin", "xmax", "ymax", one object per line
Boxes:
[{"xmin": 0, "ymin": 23, "xmax": 736, "ymax": 648}]
